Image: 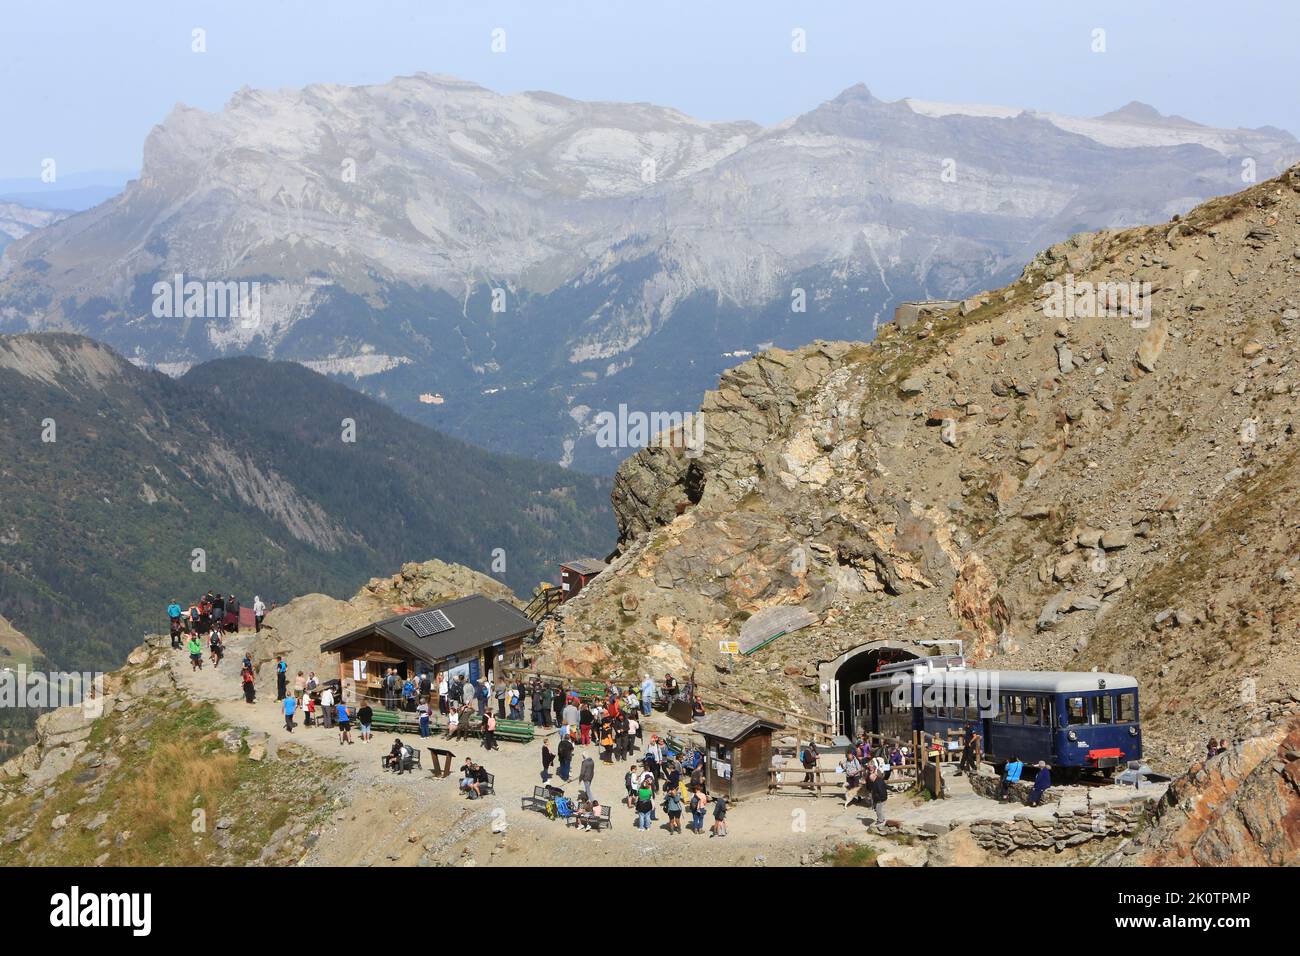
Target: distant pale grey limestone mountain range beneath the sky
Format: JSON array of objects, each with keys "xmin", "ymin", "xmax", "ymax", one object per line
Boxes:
[{"xmin": 0, "ymin": 74, "xmax": 1300, "ymax": 472}]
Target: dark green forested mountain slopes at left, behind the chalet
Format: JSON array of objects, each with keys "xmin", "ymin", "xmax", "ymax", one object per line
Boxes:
[{"xmin": 0, "ymin": 333, "xmax": 614, "ymax": 669}]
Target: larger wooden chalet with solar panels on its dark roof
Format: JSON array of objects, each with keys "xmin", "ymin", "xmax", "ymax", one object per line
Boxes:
[{"xmin": 321, "ymin": 594, "xmax": 534, "ymax": 696}]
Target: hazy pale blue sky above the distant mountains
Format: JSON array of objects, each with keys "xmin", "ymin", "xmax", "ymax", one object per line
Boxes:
[{"xmin": 0, "ymin": 0, "xmax": 1300, "ymax": 177}]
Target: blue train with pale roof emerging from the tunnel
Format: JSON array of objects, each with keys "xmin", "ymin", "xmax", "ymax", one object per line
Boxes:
[{"xmin": 852, "ymin": 658, "xmax": 1141, "ymax": 779}]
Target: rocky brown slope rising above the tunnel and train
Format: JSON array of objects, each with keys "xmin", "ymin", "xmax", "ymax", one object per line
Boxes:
[{"xmin": 542, "ymin": 169, "xmax": 1300, "ymax": 769}]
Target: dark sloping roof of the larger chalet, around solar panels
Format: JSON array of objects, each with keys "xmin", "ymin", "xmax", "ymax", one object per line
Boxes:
[{"xmin": 321, "ymin": 594, "xmax": 534, "ymax": 663}]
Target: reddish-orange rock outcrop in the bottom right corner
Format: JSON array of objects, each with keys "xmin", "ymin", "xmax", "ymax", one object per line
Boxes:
[{"xmin": 1112, "ymin": 718, "xmax": 1300, "ymax": 866}]
